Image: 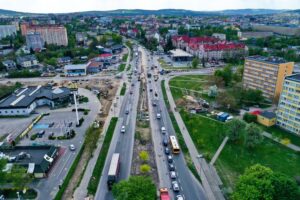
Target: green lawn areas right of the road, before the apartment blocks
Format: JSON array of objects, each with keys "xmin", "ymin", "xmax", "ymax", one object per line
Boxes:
[{"xmin": 170, "ymin": 75, "xmax": 300, "ymax": 188}]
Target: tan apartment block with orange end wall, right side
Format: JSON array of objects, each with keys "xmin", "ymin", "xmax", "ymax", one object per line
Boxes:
[{"xmin": 243, "ymin": 56, "xmax": 294, "ymax": 102}]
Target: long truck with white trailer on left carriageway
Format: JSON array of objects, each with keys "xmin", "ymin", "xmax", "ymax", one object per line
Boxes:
[{"xmin": 107, "ymin": 153, "xmax": 120, "ymax": 190}]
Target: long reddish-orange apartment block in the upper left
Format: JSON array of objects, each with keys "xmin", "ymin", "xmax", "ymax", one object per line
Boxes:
[{"xmin": 21, "ymin": 23, "xmax": 68, "ymax": 46}]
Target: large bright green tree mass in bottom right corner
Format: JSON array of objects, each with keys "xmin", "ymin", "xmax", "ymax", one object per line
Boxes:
[{"xmin": 231, "ymin": 164, "xmax": 299, "ymax": 200}]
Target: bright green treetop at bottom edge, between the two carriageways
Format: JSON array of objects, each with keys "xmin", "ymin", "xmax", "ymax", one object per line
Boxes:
[{"xmin": 112, "ymin": 176, "xmax": 156, "ymax": 200}]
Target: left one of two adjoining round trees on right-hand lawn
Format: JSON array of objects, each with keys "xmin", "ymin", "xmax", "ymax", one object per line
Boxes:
[{"xmin": 225, "ymin": 119, "xmax": 246, "ymax": 142}]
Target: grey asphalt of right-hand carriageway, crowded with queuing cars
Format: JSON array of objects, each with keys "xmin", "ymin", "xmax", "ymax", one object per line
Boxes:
[{"xmin": 142, "ymin": 49, "xmax": 206, "ymax": 200}]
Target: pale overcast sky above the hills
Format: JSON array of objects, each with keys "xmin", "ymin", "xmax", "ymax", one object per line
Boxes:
[{"xmin": 0, "ymin": 0, "xmax": 300, "ymax": 13}]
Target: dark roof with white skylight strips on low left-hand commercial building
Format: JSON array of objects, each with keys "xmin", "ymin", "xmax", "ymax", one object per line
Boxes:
[{"xmin": 0, "ymin": 86, "xmax": 70, "ymax": 109}]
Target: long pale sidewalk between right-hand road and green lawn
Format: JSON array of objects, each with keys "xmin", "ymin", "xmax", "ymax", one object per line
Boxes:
[{"xmin": 165, "ymin": 78, "xmax": 225, "ymax": 200}]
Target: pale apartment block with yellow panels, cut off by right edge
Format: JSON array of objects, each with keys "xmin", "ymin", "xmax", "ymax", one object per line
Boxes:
[{"xmin": 277, "ymin": 74, "xmax": 300, "ymax": 136}]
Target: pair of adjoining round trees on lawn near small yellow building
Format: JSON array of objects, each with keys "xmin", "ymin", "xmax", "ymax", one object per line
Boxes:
[{"xmin": 225, "ymin": 119, "xmax": 263, "ymax": 149}]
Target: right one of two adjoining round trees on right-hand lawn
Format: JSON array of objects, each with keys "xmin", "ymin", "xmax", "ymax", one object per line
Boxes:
[{"xmin": 245, "ymin": 123, "xmax": 263, "ymax": 148}]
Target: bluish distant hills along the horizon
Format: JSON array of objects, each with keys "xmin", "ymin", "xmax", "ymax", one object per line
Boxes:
[{"xmin": 0, "ymin": 9, "xmax": 292, "ymax": 16}]
